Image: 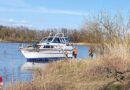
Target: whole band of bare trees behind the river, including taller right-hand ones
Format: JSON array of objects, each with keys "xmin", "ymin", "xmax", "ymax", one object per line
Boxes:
[{"xmin": 0, "ymin": 13, "xmax": 130, "ymax": 44}]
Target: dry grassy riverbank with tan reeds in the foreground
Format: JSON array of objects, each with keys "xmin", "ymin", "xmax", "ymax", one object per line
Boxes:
[{"xmin": 3, "ymin": 46, "xmax": 130, "ymax": 90}]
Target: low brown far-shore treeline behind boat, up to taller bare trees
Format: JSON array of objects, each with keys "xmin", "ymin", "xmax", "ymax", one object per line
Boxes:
[{"xmin": 0, "ymin": 26, "xmax": 104, "ymax": 43}]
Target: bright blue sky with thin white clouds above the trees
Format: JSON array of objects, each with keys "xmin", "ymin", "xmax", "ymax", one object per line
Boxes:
[{"xmin": 0, "ymin": 0, "xmax": 130, "ymax": 30}]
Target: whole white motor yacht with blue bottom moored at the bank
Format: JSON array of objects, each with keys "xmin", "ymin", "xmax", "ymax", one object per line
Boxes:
[{"xmin": 20, "ymin": 33, "xmax": 73, "ymax": 62}]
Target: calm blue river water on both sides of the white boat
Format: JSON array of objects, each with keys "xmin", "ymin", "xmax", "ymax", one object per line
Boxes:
[{"xmin": 0, "ymin": 43, "xmax": 89, "ymax": 83}]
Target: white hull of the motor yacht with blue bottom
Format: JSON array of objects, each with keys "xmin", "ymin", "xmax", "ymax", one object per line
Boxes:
[{"xmin": 21, "ymin": 49, "xmax": 73, "ymax": 62}]
